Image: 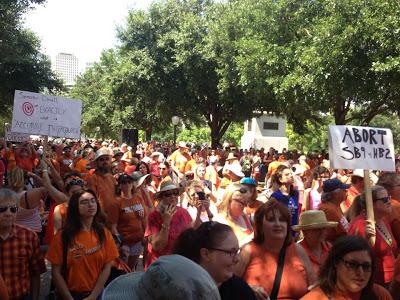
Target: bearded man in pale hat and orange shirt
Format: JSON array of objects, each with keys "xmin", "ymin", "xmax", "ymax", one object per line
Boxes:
[{"xmin": 87, "ymin": 148, "xmax": 117, "ymax": 220}]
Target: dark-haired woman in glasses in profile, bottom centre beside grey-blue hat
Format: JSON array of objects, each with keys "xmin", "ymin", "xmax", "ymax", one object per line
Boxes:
[{"xmin": 173, "ymin": 221, "xmax": 256, "ymax": 300}]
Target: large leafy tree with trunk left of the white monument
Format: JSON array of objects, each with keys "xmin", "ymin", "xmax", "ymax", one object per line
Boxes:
[{"xmin": 119, "ymin": 0, "xmax": 272, "ymax": 147}]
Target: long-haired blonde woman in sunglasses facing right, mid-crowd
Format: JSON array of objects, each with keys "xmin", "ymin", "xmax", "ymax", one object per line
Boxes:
[{"xmin": 215, "ymin": 183, "xmax": 253, "ymax": 246}]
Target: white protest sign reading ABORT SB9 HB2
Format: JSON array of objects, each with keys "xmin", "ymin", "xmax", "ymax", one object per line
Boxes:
[{"xmin": 328, "ymin": 125, "xmax": 395, "ymax": 171}]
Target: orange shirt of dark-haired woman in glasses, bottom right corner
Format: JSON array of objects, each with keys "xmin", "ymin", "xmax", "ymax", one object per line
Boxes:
[{"xmin": 300, "ymin": 284, "xmax": 393, "ymax": 300}]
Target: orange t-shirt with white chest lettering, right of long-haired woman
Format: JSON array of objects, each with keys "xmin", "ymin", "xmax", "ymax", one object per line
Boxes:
[{"xmin": 108, "ymin": 195, "xmax": 148, "ymax": 246}]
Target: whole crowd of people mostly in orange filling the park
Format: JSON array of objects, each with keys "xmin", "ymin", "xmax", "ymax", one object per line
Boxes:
[{"xmin": 0, "ymin": 140, "xmax": 400, "ymax": 300}]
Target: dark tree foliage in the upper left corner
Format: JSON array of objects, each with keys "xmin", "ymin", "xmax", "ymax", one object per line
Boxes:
[{"xmin": 0, "ymin": 0, "xmax": 62, "ymax": 117}]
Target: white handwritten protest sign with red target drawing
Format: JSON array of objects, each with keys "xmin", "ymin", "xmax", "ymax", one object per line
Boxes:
[{"xmin": 11, "ymin": 90, "xmax": 82, "ymax": 138}]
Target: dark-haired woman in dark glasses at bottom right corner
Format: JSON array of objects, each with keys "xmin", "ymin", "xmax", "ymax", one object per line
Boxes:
[{"xmin": 301, "ymin": 236, "xmax": 392, "ymax": 300}]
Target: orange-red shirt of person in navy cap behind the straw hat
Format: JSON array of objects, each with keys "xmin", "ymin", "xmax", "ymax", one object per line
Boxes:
[{"xmin": 319, "ymin": 201, "xmax": 349, "ymax": 244}]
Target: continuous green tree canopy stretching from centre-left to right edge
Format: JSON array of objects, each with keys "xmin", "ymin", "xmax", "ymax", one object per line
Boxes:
[{"xmin": 74, "ymin": 0, "xmax": 400, "ymax": 146}]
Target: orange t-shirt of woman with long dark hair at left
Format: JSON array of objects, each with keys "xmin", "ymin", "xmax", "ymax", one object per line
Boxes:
[{"xmin": 46, "ymin": 229, "xmax": 119, "ymax": 292}]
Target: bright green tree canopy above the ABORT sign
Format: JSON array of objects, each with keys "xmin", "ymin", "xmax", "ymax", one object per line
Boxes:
[{"xmin": 231, "ymin": 0, "xmax": 400, "ymax": 129}]
